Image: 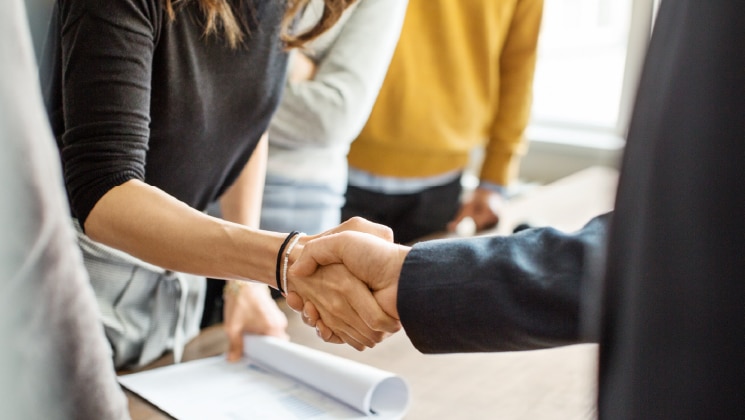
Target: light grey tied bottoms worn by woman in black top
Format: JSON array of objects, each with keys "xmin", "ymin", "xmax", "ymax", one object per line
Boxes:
[{"xmin": 75, "ymin": 223, "xmax": 206, "ymax": 368}]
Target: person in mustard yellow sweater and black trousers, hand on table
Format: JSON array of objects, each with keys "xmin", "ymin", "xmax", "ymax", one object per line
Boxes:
[{"xmin": 342, "ymin": 0, "xmax": 543, "ymax": 243}]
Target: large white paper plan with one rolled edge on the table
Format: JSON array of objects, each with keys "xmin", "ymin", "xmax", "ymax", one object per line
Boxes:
[{"xmin": 119, "ymin": 336, "xmax": 409, "ymax": 420}]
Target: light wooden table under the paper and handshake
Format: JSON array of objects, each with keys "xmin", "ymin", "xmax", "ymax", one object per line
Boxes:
[{"xmin": 127, "ymin": 167, "xmax": 617, "ymax": 420}]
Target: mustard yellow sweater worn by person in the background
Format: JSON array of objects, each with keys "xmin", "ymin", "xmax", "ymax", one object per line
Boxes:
[{"xmin": 349, "ymin": 0, "xmax": 543, "ymax": 185}]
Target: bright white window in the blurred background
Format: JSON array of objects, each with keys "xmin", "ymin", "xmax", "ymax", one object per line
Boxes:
[{"xmin": 528, "ymin": 0, "xmax": 655, "ymax": 142}]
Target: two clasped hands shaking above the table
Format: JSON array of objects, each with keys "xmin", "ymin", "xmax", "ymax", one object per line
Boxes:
[{"xmin": 286, "ymin": 217, "xmax": 410, "ymax": 350}]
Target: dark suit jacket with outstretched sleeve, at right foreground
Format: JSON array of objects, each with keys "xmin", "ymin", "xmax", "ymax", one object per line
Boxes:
[{"xmin": 398, "ymin": 0, "xmax": 745, "ymax": 419}]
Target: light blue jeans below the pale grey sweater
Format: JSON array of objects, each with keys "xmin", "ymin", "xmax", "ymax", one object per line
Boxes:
[{"xmin": 261, "ymin": 174, "xmax": 346, "ymax": 235}]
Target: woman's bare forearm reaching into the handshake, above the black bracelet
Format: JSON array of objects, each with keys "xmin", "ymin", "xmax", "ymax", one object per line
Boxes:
[{"xmin": 85, "ymin": 180, "xmax": 285, "ymax": 285}]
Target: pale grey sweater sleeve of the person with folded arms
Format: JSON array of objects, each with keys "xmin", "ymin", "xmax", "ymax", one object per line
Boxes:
[{"xmin": 270, "ymin": 0, "xmax": 406, "ymax": 147}]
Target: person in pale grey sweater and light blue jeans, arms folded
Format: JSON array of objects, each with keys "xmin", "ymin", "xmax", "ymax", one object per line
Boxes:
[{"xmin": 261, "ymin": 0, "xmax": 408, "ymax": 234}]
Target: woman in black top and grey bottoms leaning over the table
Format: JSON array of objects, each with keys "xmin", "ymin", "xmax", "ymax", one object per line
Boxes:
[{"xmin": 41, "ymin": 0, "xmax": 397, "ymax": 367}]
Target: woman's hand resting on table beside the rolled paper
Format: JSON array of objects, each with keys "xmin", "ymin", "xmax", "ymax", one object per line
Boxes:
[{"xmin": 223, "ymin": 282, "xmax": 289, "ymax": 362}]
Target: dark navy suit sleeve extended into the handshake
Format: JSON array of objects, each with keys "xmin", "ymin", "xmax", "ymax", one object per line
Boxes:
[{"xmin": 397, "ymin": 213, "xmax": 611, "ymax": 353}]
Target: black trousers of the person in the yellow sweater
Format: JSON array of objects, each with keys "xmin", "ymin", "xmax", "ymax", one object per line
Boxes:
[{"xmin": 341, "ymin": 178, "xmax": 463, "ymax": 243}]
